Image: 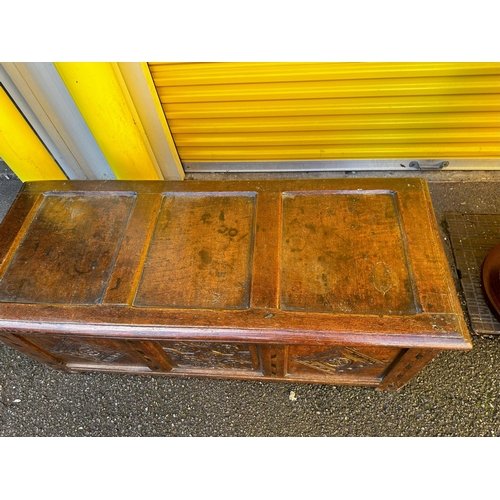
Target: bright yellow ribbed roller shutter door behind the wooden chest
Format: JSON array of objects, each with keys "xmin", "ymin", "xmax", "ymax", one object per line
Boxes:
[{"xmin": 149, "ymin": 63, "xmax": 500, "ymax": 163}]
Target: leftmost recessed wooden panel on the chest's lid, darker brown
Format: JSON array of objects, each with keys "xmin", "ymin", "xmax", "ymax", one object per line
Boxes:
[{"xmin": 0, "ymin": 193, "xmax": 135, "ymax": 305}]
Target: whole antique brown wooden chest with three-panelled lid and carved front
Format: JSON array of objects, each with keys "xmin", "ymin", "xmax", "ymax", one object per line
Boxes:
[{"xmin": 0, "ymin": 179, "xmax": 471, "ymax": 390}]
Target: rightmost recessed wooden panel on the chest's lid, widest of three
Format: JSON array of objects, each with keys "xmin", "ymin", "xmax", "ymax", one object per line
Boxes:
[{"xmin": 281, "ymin": 190, "xmax": 417, "ymax": 314}]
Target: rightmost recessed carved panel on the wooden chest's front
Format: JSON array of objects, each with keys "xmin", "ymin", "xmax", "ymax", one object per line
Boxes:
[{"xmin": 288, "ymin": 346, "xmax": 401, "ymax": 378}]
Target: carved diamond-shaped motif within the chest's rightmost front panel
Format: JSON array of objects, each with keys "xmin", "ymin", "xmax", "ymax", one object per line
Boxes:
[{"xmin": 293, "ymin": 347, "xmax": 386, "ymax": 373}]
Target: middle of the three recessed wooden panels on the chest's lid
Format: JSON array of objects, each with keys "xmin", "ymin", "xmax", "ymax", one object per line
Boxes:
[{"xmin": 134, "ymin": 192, "xmax": 255, "ymax": 309}]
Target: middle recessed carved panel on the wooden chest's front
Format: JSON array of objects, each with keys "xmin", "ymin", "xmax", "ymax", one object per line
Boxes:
[{"xmin": 163, "ymin": 342, "xmax": 253, "ymax": 370}]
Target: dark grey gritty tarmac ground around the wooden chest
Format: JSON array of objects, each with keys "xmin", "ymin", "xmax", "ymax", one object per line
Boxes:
[{"xmin": 0, "ymin": 163, "xmax": 500, "ymax": 436}]
